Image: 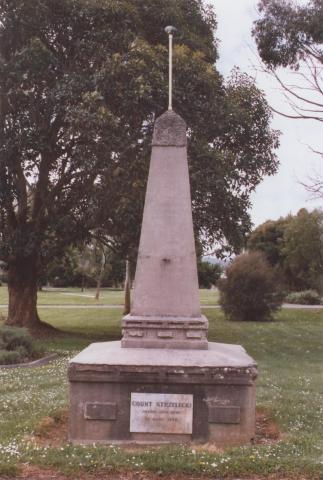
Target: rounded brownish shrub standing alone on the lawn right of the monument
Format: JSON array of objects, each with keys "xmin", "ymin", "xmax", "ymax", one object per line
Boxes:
[{"xmin": 218, "ymin": 252, "xmax": 282, "ymax": 321}]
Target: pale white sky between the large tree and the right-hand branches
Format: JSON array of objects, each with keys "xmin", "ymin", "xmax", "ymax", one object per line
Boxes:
[{"xmin": 208, "ymin": 0, "xmax": 323, "ymax": 226}]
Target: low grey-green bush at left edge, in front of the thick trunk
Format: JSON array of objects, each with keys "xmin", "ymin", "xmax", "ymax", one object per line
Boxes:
[{"xmin": 0, "ymin": 325, "xmax": 42, "ymax": 365}]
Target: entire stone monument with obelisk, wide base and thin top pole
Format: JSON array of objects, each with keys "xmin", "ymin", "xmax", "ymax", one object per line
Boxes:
[{"xmin": 68, "ymin": 27, "xmax": 257, "ymax": 446}]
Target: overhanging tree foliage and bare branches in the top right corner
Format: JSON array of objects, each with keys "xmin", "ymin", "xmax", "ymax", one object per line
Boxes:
[{"xmin": 253, "ymin": 0, "xmax": 323, "ymax": 197}]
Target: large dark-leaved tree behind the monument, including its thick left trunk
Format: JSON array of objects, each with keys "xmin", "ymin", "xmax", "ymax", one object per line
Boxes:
[{"xmin": 0, "ymin": 0, "xmax": 278, "ymax": 327}]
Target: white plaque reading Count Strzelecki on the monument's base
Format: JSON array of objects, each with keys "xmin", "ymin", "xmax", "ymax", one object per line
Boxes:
[{"xmin": 130, "ymin": 393, "xmax": 193, "ymax": 434}]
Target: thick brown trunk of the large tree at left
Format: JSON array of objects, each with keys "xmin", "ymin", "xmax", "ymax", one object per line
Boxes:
[{"xmin": 6, "ymin": 257, "xmax": 42, "ymax": 328}]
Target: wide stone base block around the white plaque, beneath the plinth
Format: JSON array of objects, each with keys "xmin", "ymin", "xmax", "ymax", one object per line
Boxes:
[{"xmin": 68, "ymin": 342, "xmax": 257, "ymax": 446}]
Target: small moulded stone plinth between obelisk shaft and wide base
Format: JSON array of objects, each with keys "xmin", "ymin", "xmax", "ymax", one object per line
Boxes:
[{"xmin": 121, "ymin": 314, "xmax": 208, "ymax": 350}]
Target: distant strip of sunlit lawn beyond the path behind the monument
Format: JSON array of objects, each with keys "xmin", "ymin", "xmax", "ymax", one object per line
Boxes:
[{"xmin": 0, "ymin": 286, "xmax": 219, "ymax": 305}]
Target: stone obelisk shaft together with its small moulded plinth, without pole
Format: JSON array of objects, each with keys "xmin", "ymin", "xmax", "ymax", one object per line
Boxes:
[{"xmin": 122, "ymin": 110, "xmax": 207, "ymax": 349}]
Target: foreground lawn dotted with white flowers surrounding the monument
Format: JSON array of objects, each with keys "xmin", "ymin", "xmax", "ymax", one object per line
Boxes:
[{"xmin": 0, "ymin": 309, "xmax": 323, "ymax": 478}]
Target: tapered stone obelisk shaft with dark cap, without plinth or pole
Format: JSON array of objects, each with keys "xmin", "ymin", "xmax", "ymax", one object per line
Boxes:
[{"xmin": 131, "ymin": 111, "xmax": 201, "ymax": 317}]
